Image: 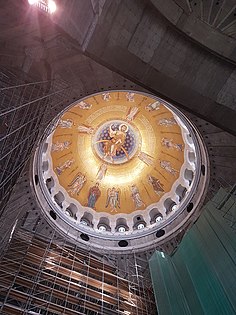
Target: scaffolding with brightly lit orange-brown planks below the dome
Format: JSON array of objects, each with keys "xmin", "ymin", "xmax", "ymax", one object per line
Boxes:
[{"xmin": 0, "ymin": 229, "xmax": 156, "ymax": 315}]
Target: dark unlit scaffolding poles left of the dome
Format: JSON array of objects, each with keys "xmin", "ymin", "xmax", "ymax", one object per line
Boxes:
[{"xmin": 0, "ymin": 68, "xmax": 70, "ymax": 217}]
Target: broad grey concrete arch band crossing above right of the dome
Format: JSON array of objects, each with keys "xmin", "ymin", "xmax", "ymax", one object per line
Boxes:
[{"xmin": 77, "ymin": 0, "xmax": 236, "ymax": 133}]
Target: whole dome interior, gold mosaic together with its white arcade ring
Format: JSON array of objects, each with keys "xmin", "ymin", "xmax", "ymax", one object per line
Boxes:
[{"xmin": 33, "ymin": 91, "xmax": 208, "ymax": 252}]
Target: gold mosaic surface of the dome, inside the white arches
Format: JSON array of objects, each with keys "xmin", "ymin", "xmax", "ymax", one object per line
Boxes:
[{"xmin": 49, "ymin": 91, "xmax": 186, "ymax": 215}]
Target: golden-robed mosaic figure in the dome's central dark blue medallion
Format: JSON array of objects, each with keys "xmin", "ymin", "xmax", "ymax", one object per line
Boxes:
[{"xmin": 97, "ymin": 124, "xmax": 129, "ymax": 160}]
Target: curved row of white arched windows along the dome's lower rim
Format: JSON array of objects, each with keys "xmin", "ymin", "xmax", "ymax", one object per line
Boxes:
[{"xmin": 40, "ymin": 175, "xmax": 194, "ymax": 233}]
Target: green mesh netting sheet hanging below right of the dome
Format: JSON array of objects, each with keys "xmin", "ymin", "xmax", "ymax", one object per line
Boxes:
[{"xmin": 149, "ymin": 195, "xmax": 236, "ymax": 315}]
